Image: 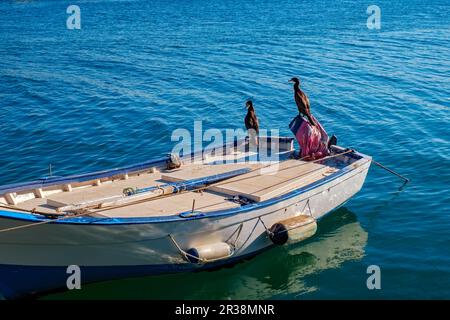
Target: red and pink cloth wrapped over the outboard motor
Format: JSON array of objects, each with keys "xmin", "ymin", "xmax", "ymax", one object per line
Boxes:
[{"xmin": 289, "ymin": 115, "xmax": 329, "ymax": 160}]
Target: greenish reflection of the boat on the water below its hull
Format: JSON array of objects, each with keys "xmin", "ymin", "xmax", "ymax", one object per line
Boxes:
[{"xmin": 45, "ymin": 208, "xmax": 368, "ymax": 299}]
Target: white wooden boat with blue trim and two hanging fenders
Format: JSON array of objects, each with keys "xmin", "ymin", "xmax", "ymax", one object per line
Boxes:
[{"xmin": 0, "ymin": 137, "xmax": 371, "ymax": 299}]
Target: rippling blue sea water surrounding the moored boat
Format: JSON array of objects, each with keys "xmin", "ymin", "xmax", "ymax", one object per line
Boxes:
[{"xmin": 0, "ymin": 0, "xmax": 450, "ymax": 299}]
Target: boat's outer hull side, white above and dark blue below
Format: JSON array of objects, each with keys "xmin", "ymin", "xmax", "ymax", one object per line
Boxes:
[{"xmin": 0, "ymin": 158, "xmax": 370, "ymax": 298}]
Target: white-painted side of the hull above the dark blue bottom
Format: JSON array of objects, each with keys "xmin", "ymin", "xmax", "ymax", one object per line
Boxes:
[{"xmin": 0, "ymin": 158, "xmax": 370, "ymax": 266}]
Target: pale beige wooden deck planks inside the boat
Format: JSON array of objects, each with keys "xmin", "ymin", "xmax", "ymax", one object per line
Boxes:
[{"xmin": 0, "ymin": 149, "xmax": 338, "ymax": 217}]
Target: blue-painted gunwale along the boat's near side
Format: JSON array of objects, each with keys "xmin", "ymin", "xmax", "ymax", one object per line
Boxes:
[{"xmin": 0, "ymin": 145, "xmax": 372, "ymax": 226}]
